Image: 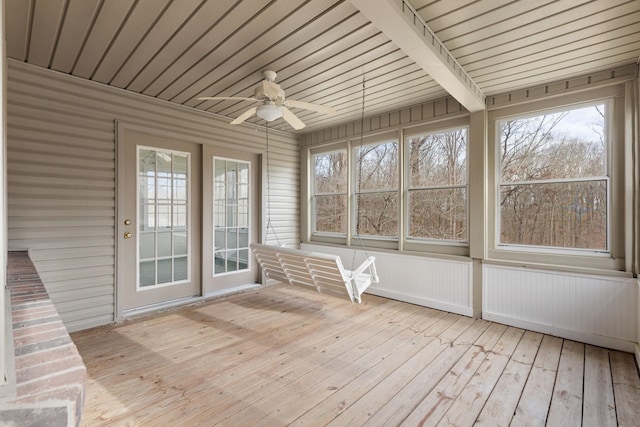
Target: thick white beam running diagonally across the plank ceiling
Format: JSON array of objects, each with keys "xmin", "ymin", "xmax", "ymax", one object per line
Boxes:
[{"xmin": 350, "ymin": 0, "xmax": 485, "ymax": 112}]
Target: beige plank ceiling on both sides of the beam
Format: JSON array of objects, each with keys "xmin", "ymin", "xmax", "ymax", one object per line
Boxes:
[{"xmin": 6, "ymin": 0, "xmax": 640, "ymax": 133}]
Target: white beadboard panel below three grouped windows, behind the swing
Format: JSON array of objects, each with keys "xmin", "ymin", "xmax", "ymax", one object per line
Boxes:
[{"xmin": 302, "ymin": 243, "xmax": 473, "ymax": 316}]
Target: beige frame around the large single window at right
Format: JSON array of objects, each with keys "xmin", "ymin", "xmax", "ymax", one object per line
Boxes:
[{"xmin": 487, "ymin": 86, "xmax": 625, "ymax": 270}]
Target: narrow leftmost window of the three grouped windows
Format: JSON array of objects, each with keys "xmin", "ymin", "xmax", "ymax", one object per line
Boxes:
[{"xmin": 312, "ymin": 150, "xmax": 349, "ymax": 235}]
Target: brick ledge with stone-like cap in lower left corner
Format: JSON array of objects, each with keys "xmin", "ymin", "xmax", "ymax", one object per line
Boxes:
[{"xmin": 0, "ymin": 252, "xmax": 86, "ymax": 426}]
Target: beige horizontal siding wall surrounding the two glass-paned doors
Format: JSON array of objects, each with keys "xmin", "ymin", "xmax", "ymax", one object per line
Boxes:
[{"xmin": 7, "ymin": 61, "xmax": 300, "ymax": 331}]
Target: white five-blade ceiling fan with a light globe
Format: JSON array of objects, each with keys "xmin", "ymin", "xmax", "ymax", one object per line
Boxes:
[{"xmin": 198, "ymin": 70, "xmax": 336, "ymax": 130}]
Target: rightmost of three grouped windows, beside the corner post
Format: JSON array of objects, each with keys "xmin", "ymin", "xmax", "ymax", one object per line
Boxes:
[{"xmin": 406, "ymin": 127, "xmax": 468, "ymax": 242}]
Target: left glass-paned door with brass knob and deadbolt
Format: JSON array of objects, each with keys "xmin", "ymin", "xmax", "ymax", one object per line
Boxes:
[{"xmin": 118, "ymin": 129, "xmax": 202, "ymax": 312}]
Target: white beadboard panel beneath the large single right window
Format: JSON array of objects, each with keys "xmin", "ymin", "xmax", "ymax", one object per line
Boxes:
[{"xmin": 482, "ymin": 264, "xmax": 638, "ymax": 352}]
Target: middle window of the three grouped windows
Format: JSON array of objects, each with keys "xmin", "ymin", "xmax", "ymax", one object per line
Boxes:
[{"xmin": 353, "ymin": 141, "xmax": 400, "ymax": 238}]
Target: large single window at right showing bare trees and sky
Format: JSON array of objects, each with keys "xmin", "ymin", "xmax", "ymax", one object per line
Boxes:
[{"xmin": 496, "ymin": 103, "xmax": 611, "ymax": 252}]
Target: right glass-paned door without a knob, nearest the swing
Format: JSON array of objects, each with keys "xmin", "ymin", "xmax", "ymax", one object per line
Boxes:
[{"xmin": 202, "ymin": 146, "xmax": 260, "ymax": 294}]
